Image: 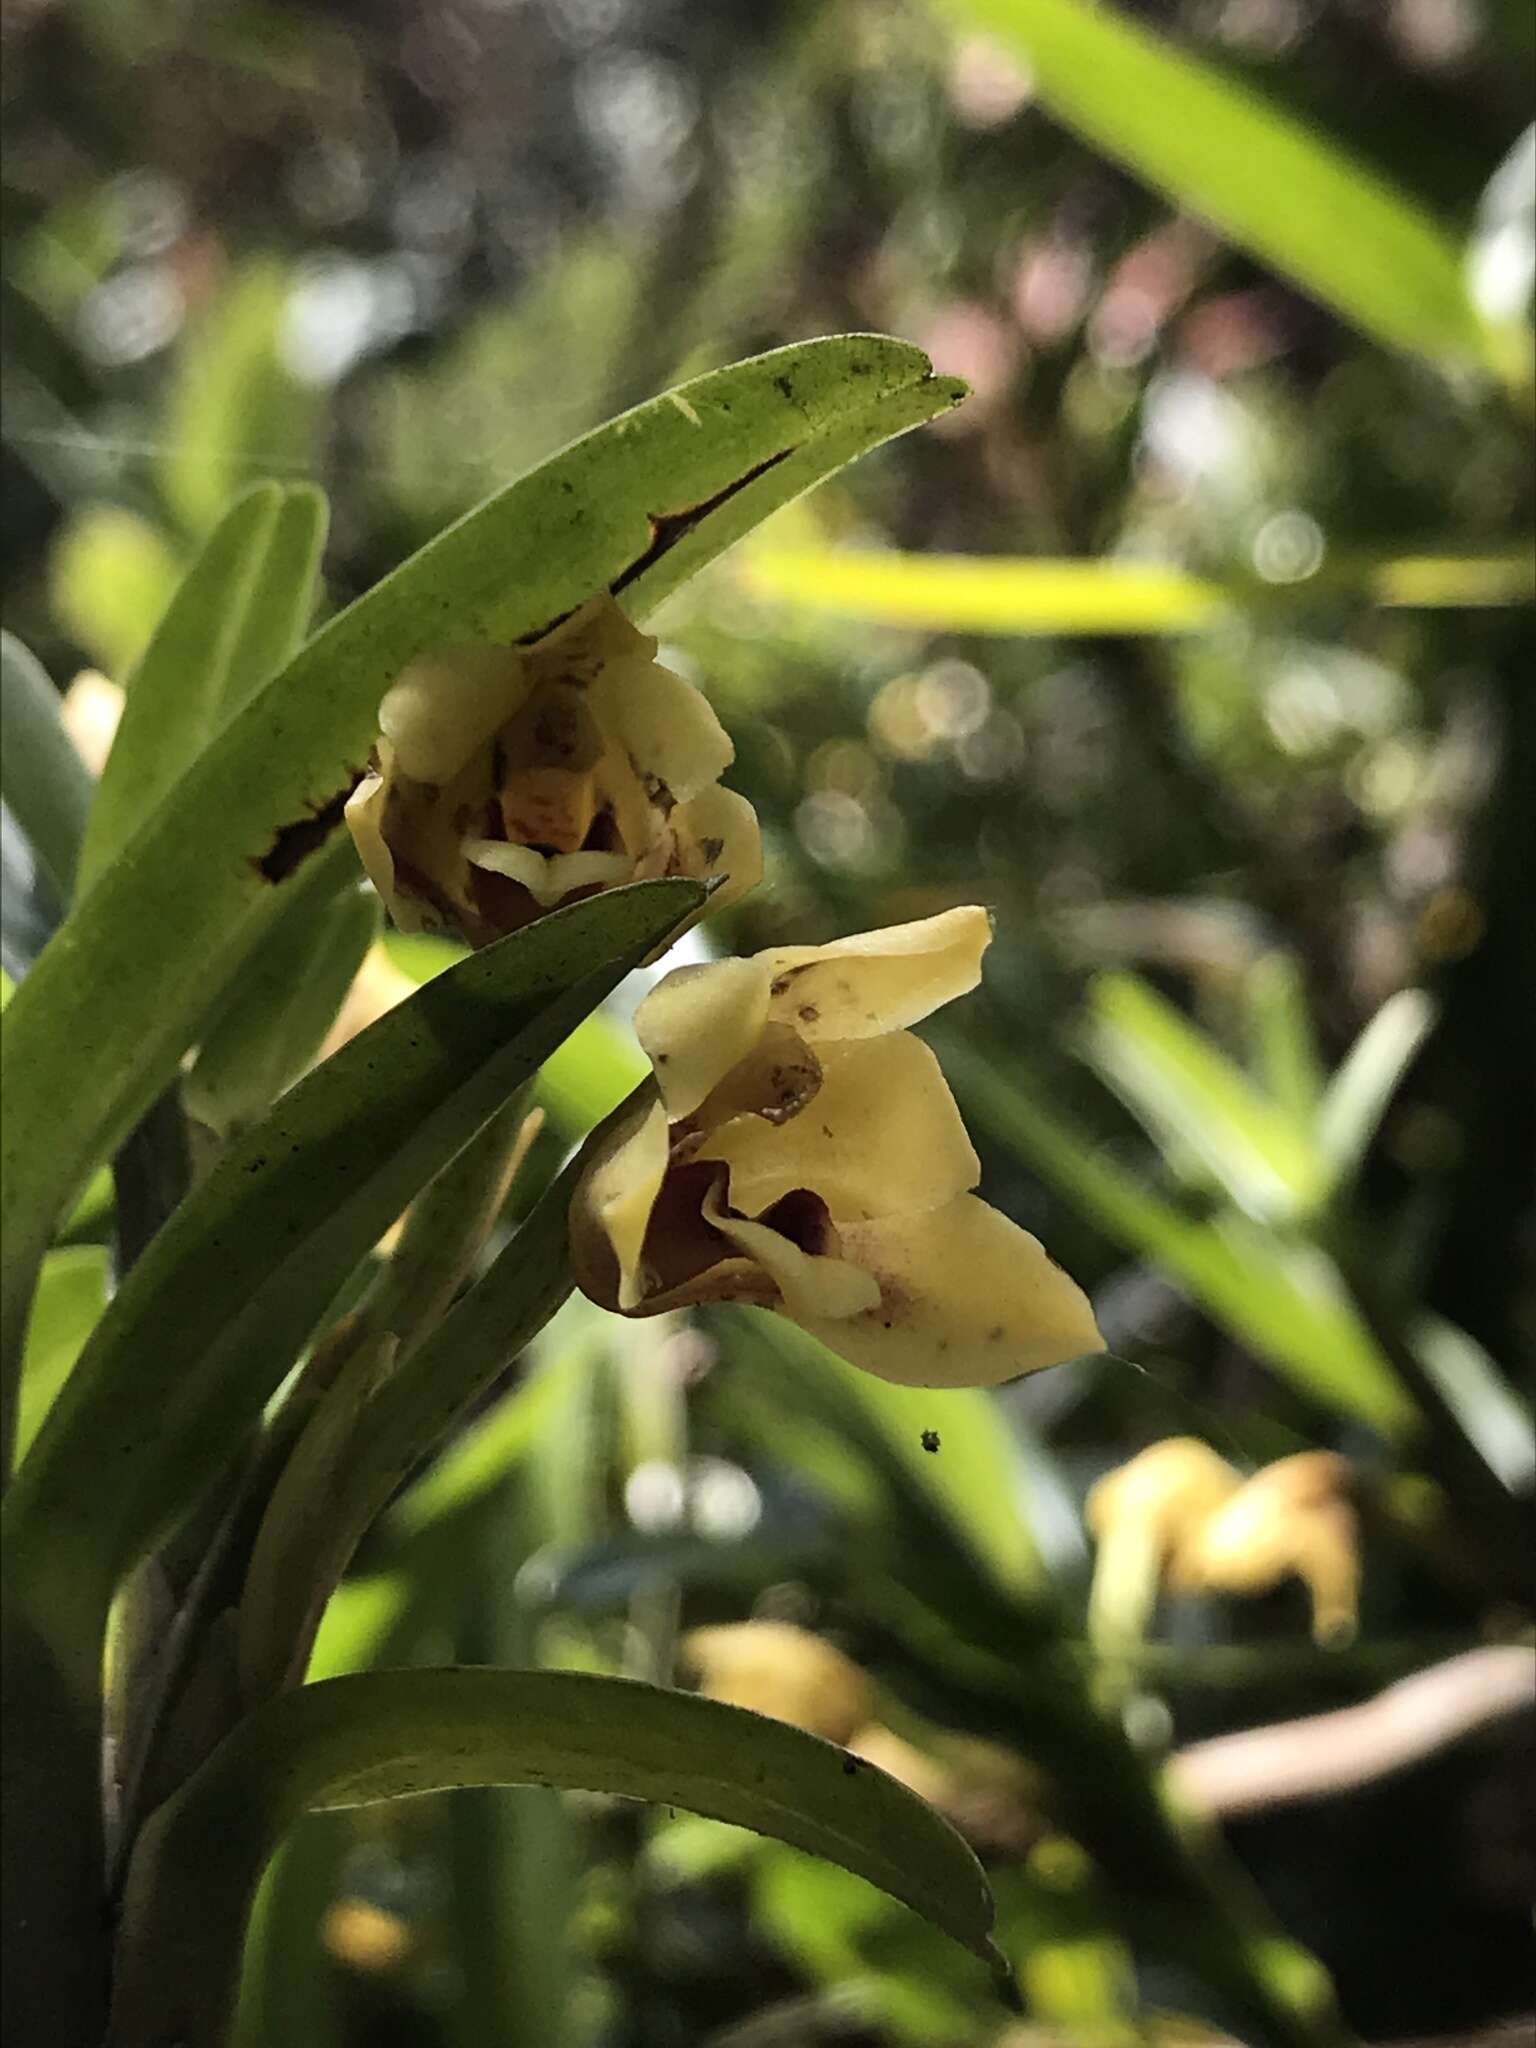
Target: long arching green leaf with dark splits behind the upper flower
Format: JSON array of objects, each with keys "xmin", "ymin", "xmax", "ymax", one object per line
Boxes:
[{"xmin": 0, "ymin": 336, "xmax": 963, "ymax": 1417}]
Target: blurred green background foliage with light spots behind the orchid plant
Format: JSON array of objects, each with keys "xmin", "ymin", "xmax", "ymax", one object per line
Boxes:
[{"xmin": 0, "ymin": 0, "xmax": 1536, "ymax": 2048}]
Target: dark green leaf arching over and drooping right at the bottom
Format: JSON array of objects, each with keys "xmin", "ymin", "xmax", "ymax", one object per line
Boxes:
[{"xmin": 111, "ymin": 1669, "xmax": 997, "ymax": 2048}]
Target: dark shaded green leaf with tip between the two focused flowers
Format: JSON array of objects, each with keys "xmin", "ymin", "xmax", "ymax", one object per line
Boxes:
[{"xmin": 4, "ymin": 881, "xmax": 702, "ymax": 1636}]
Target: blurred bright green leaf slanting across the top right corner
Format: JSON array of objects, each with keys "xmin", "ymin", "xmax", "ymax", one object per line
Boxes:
[{"xmin": 942, "ymin": 0, "xmax": 1511, "ymax": 373}]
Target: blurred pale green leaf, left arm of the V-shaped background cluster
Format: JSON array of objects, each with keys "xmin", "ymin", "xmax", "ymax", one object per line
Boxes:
[{"xmin": 1083, "ymin": 973, "xmax": 1327, "ymax": 1219}]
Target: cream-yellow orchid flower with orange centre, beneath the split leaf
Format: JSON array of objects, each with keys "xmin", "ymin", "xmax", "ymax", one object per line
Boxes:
[{"xmin": 346, "ymin": 596, "xmax": 762, "ymax": 946}]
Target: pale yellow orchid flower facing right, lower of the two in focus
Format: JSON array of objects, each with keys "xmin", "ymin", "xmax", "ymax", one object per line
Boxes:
[{"xmin": 571, "ymin": 907, "xmax": 1104, "ymax": 1386}]
